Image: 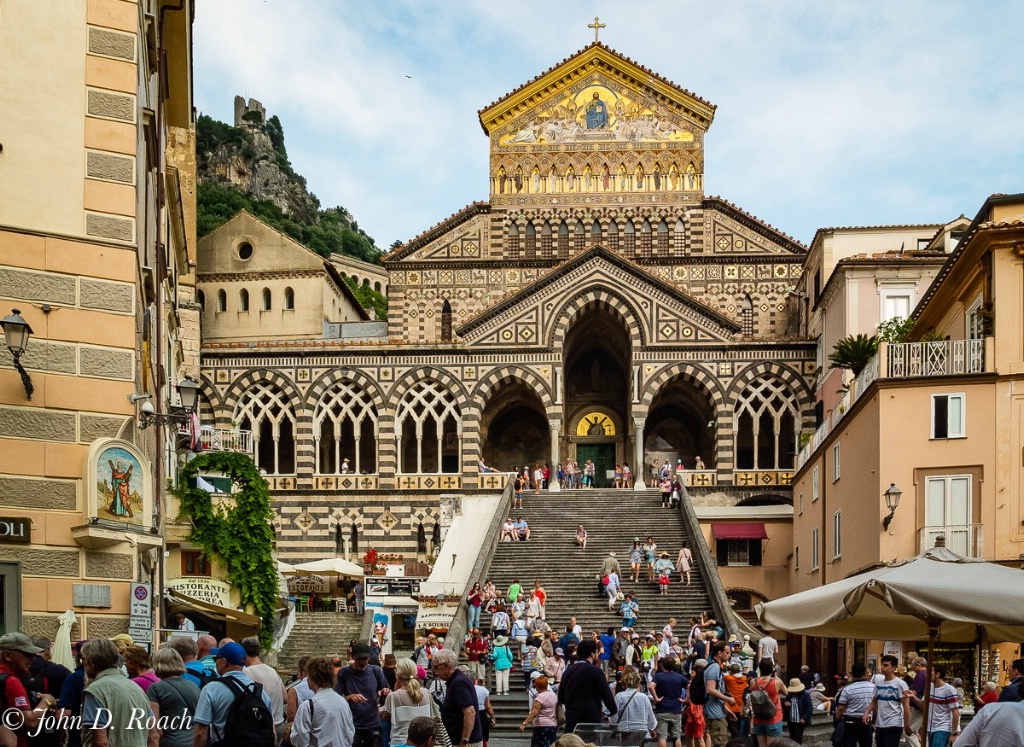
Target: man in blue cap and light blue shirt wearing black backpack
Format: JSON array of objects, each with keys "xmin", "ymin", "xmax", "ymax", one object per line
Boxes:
[{"xmin": 193, "ymin": 641, "xmax": 278, "ymax": 747}]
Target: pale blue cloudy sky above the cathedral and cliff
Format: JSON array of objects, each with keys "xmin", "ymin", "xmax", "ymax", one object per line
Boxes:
[{"xmin": 195, "ymin": 0, "xmax": 1024, "ymax": 248}]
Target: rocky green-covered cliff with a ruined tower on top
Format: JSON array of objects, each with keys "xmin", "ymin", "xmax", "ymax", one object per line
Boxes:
[{"xmin": 196, "ymin": 96, "xmax": 381, "ymax": 263}]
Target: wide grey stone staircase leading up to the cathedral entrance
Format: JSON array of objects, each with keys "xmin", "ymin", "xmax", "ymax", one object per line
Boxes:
[{"xmin": 480, "ymin": 489, "xmax": 714, "ymax": 742}]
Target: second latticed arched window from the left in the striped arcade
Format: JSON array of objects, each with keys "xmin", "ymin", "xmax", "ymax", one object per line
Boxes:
[{"xmin": 313, "ymin": 381, "xmax": 379, "ymax": 474}]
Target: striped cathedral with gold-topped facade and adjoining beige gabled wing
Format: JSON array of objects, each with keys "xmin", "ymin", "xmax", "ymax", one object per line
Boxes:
[{"xmin": 198, "ymin": 42, "xmax": 818, "ymax": 563}]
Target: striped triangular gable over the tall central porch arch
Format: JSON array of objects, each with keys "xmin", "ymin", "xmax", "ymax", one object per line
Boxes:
[{"xmin": 457, "ymin": 246, "xmax": 739, "ymax": 347}]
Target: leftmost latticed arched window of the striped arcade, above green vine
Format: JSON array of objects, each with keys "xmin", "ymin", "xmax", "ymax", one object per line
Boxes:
[{"xmin": 232, "ymin": 381, "xmax": 295, "ymax": 474}]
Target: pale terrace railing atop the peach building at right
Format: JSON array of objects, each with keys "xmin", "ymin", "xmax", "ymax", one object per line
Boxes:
[{"xmin": 797, "ymin": 339, "xmax": 986, "ymax": 469}]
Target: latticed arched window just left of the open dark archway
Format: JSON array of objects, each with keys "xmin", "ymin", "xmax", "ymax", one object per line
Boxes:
[{"xmin": 395, "ymin": 379, "xmax": 462, "ymax": 473}]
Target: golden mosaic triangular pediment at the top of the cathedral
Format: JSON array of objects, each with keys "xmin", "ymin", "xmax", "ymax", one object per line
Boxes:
[{"xmin": 479, "ymin": 42, "xmax": 715, "ymax": 146}]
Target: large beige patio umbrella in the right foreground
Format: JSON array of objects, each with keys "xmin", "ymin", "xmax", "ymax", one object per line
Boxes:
[{"xmin": 755, "ymin": 538, "xmax": 1024, "ymax": 745}]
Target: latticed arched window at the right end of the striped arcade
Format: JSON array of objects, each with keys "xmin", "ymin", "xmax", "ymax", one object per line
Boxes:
[{"xmin": 735, "ymin": 376, "xmax": 799, "ymax": 469}]
